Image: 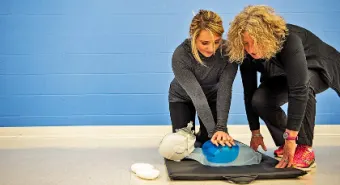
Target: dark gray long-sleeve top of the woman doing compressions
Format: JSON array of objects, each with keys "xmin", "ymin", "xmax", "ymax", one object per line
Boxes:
[{"xmin": 169, "ymin": 39, "xmax": 238, "ymax": 137}]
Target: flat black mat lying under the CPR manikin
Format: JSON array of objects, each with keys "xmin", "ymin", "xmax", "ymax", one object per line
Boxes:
[{"xmin": 164, "ymin": 140, "xmax": 307, "ymax": 184}]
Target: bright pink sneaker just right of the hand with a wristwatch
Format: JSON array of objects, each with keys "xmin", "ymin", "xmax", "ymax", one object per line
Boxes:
[{"xmin": 293, "ymin": 145, "xmax": 316, "ymax": 171}]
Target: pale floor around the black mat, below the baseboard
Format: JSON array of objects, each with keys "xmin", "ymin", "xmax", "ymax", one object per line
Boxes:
[{"xmin": 0, "ymin": 126, "xmax": 340, "ymax": 185}]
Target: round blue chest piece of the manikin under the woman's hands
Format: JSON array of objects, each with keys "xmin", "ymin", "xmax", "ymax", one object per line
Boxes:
[{"xmin": 202, "ymin": 140, "xmax": 240, "ymax": 163}]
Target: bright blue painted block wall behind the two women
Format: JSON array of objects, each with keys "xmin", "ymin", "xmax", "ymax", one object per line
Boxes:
[{"xmin": 0, "ymin": 0, "xmax": 340, "ymax": 126}]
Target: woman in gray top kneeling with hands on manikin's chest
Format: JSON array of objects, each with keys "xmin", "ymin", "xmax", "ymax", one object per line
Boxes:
[{"xmin": 168, "ymin": 10, "xmax": 238, "ymax": 146}]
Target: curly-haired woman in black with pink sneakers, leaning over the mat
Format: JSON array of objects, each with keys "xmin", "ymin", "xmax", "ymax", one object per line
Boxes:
[{"xmin": 227, "ymin": 5, "xmax": 340, "ymax": 170}]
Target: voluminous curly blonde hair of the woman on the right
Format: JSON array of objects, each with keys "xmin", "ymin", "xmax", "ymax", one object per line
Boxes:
[{"xmin": 226, "ymin": 5, "xmax": 288, "ymax": 63}]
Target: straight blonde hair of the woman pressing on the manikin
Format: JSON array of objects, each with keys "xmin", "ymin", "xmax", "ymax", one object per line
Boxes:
[{"xmin": 189, "ymin": 10, "xmax": 224, "ymax": 65}]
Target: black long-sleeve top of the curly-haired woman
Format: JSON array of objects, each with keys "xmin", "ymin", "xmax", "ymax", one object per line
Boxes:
[{"xmin": 240, "ymin": 24, "xmax": 340, "ymax": 131}]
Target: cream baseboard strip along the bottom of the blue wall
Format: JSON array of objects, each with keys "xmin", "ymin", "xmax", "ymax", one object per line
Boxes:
[{"xmin": 0, "ymin": 125, "xmax": 340, "ymax": 138}]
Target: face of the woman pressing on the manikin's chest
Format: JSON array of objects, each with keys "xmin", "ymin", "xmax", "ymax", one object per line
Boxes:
[{"xmin": 196, "ymin": 30, "xmax": 222, "ymax": 57}]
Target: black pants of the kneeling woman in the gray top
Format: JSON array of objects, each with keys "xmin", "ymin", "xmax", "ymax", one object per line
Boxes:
[{"xmin": 169, "ymin": 102, "xmax": 217, "ymax": 143}]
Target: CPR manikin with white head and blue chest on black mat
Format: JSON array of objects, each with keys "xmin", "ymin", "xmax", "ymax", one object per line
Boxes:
[{"xmin": 159, "ymin": 122, "xmax": 262, "ymax": 166}]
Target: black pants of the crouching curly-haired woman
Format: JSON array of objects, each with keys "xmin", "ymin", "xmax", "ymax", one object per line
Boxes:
[{"xmin": 252, "ymin": 70, "xmax": 328, "ymax": 146}]
